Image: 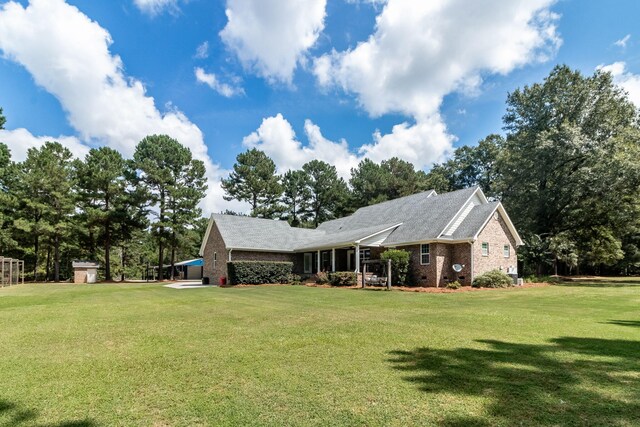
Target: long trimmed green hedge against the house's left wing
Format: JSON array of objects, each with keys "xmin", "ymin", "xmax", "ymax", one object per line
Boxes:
[{"xmin": 227, "ymin": 261, "xmax": 293, "ymax": 285}]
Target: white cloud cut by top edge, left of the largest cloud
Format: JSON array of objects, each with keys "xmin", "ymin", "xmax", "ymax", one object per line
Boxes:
[{"xmin": 220, "ymin": 0, "xmax": 326, "ymax": 83}]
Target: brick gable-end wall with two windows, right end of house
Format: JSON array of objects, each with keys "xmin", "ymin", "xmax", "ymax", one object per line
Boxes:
[{"xmin": 473, "ymin": 214, "xmax": 518, "ymax": 277}]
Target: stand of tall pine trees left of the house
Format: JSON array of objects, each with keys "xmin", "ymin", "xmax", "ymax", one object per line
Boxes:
[{"xmin": 0, "ymin": 129, "xmax": 207, "ymax": 281}]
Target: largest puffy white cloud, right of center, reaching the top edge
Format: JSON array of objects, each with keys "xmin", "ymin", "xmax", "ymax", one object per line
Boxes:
[{"xmin": 313, "ymin": 0, "xmax": 561, "ymax": 167}]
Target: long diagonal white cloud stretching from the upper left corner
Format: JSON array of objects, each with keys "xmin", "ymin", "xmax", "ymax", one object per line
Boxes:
[{"xmin": 0, "ymin": 0, "xmax": 245, "ymax": 212}]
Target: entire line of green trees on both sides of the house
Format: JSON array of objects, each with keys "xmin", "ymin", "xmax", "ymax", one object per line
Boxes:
[{"xmin": 0, "ymin": 66, "xmax": 640, "ymax": 280}]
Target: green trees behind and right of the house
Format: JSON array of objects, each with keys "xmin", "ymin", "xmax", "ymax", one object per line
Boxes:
[{"xmin": 222, "ymin": 66, "xmax": 640, "ymax": 274}]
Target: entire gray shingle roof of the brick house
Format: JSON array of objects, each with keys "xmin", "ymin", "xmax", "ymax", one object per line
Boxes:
[{"xmin": 212, "ymin": 187, "xmax": 498, "ymax": 252}]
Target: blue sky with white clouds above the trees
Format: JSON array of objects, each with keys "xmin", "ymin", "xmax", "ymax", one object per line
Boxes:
[{"xmin": 0, "ymin": 0, "xmax": 640, "ymax": 212}]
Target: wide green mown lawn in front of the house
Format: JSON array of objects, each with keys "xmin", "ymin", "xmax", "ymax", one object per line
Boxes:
[{"xmin": 0, "ymin": 283, "xmax": 640, "ymax": 427}]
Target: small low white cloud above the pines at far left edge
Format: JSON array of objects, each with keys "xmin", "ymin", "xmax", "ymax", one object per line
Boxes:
[{"xmin": 0, "ymin": 128, "xmax": 90, "ymax": 162}]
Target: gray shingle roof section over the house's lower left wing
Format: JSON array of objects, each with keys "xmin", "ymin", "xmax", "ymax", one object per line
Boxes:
[{"xmin": 211, "ymin": 214, "xmax": 324, "ymax": 252}]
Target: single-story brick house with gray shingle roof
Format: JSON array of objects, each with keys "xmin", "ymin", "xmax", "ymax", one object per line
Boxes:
[{"xmin": 200, "ymin": 187, "xmax": 523, "ymax": 286}]
